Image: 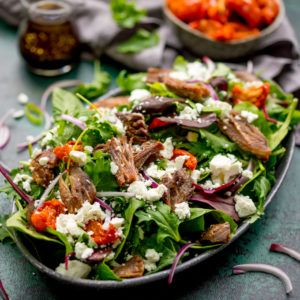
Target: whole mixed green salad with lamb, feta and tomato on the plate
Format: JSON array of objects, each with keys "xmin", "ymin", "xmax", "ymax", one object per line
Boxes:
[{"xmin": 0, "ymin": 57, "xmax": 299, "ymax": 282}]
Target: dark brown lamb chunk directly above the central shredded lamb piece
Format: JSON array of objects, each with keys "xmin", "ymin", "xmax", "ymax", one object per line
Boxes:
[{"xmin": 117, "ymin": 113, "xmax": 149, "ymax": 144}]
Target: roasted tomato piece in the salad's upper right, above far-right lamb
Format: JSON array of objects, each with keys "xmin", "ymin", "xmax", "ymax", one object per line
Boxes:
[{"xmin": 232, "ymin": 82, "xmax": 270, "ymax": 107}]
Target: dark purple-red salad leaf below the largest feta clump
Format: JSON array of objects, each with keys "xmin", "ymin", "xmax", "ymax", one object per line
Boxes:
[{"xmin": 189, "ymin": 191, "xmax": 240, "ymax": 222}]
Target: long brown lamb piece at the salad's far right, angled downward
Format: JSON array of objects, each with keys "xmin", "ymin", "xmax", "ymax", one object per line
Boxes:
[{"xmin": 218, "ymin": 113, "xmax": 271, "ymax": 160}]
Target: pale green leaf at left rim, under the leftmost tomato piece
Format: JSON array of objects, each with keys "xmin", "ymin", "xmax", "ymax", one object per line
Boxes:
[{"xmin": 6, "ymin": 209, "xmax": 62, "ymax": 244}]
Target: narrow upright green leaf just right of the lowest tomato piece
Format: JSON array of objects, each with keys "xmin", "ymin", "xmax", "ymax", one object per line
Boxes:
[{"xmin": 115, "ymin": 198, "xmax": 144, "ymax": 259}]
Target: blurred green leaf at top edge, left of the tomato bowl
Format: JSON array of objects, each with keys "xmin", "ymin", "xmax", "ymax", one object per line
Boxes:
[{"xmin": 110, "ymin": 0, "xmax": 146, "ymax": 28}]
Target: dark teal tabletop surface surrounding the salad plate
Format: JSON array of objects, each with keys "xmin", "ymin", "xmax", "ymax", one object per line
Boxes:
[{"xmin": 0, "ymin": 0, "xmax": 300, "ymax": 300}]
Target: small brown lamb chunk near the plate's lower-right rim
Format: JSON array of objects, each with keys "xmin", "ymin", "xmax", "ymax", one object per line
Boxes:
[{"xmin": 201, "ymin": 222, "xmax": 230, "ymax": 244}]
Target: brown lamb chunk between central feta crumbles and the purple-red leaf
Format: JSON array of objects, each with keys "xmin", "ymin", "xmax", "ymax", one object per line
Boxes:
[{"xmin": 161, "ymin": 169, "xmax": 194, "ymax": 210}]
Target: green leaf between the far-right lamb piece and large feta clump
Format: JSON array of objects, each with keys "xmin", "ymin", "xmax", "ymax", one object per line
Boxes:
[{"xmin": 199, "ymin": 129, "xmax": 236, "ymax": 152}]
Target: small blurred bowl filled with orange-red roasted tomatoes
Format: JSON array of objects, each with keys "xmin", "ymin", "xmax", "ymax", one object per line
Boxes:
[{"xmin": 164, "ymin": 0, "xmax": 285, "ymax": 60}]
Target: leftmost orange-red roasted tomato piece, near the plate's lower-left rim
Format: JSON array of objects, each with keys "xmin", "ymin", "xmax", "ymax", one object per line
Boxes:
[{"xmin": 30, "ymin": 199, "xmax": 65, "ymax": 231}]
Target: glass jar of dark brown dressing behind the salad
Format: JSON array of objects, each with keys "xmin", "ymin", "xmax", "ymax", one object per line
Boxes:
[{"xmin": 19, "ymin": 0, "xmax": 80, "ymax": 76}]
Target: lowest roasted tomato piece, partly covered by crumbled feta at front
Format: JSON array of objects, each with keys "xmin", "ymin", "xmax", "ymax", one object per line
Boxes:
[{"xmin": 85, "ymin": 220, "xmax": 119, "ymax": 245}]
